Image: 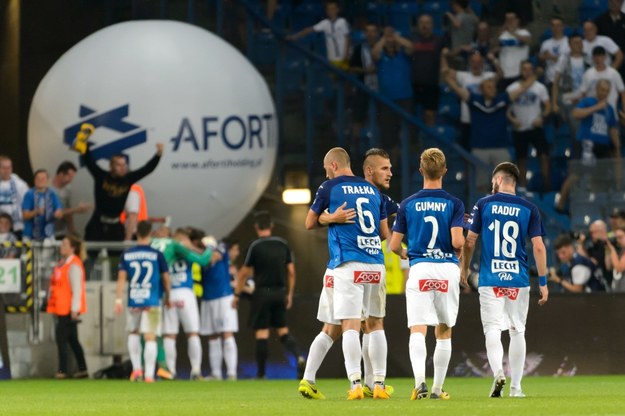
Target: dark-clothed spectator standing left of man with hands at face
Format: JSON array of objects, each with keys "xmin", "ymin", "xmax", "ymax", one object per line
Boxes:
[{"xmin": 349, "ymin": 24, "xmax": 380, "ymax": 148}]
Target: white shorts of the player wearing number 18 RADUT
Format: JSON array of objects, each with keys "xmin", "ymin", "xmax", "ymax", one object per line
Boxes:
[{"xmin": 478, "ymin": 286, "xmax": 530, "ymax": 334}]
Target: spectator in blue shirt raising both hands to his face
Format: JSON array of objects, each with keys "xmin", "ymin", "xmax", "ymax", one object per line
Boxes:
[{"xmin": 372, "ymin": 26, "xmax": 413, "ymax": 154}]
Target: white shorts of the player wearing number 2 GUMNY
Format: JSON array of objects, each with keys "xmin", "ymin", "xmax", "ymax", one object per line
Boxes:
[{"xmin": 406, "ymin": 263, "xmax": 460, "ymax": 328}]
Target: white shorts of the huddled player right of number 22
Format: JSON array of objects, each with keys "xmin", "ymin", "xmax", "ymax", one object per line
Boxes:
[{"xmin": 163, "ymin": 287, "xmax": 200, "ymax": 335}]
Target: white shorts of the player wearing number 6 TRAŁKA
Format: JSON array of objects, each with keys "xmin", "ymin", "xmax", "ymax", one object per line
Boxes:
[{"xmin": 332, "ymin": 261, "xmax": 386, "ymax": 320}]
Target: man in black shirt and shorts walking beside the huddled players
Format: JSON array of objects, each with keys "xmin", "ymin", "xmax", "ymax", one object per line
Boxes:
[{"xmin": 232, "ymin": 211, "xmax": 306, "ymax": 378}]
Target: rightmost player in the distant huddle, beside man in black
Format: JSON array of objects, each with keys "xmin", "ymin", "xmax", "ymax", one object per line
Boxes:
[{"xmin": 200, "ymin": 237, "xmax": 239, "ymax": 380}]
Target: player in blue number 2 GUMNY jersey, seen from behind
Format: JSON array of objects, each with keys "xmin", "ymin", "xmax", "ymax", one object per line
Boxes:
[{"xmin": 391, "ymin": 148, "xmax": 464, "ymax": 400}]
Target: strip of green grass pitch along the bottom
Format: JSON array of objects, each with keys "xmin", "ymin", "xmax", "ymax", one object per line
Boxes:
[{"xmin": 0, "ymin": 376, "xmax": 625, "ymax": 416}]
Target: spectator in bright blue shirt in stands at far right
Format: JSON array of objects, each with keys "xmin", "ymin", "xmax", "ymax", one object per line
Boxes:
[{"xmin": 555, "ymin": 80, "xmax": 620, "ymax": 212}]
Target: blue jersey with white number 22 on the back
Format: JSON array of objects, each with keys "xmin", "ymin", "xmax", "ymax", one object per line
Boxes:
[{"xmin": 119, "ymin": 245, "xmax": 167, "ymax": 308}]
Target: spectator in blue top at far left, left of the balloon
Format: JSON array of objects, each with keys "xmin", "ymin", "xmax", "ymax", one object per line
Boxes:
[{"xmin": 22, "ymin": 169, "xmax": 63, "ymax": 241}]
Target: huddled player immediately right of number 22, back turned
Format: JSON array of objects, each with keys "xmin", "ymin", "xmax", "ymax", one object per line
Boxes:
[{"xmin": 160, "ymin": 229, "xmax": 213, "ymax": 380}]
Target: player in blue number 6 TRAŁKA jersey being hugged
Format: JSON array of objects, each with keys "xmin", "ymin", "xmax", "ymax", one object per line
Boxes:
[{"xmin": 305, "ymin": 147, "xmax": 390, "ymax": 400}]
